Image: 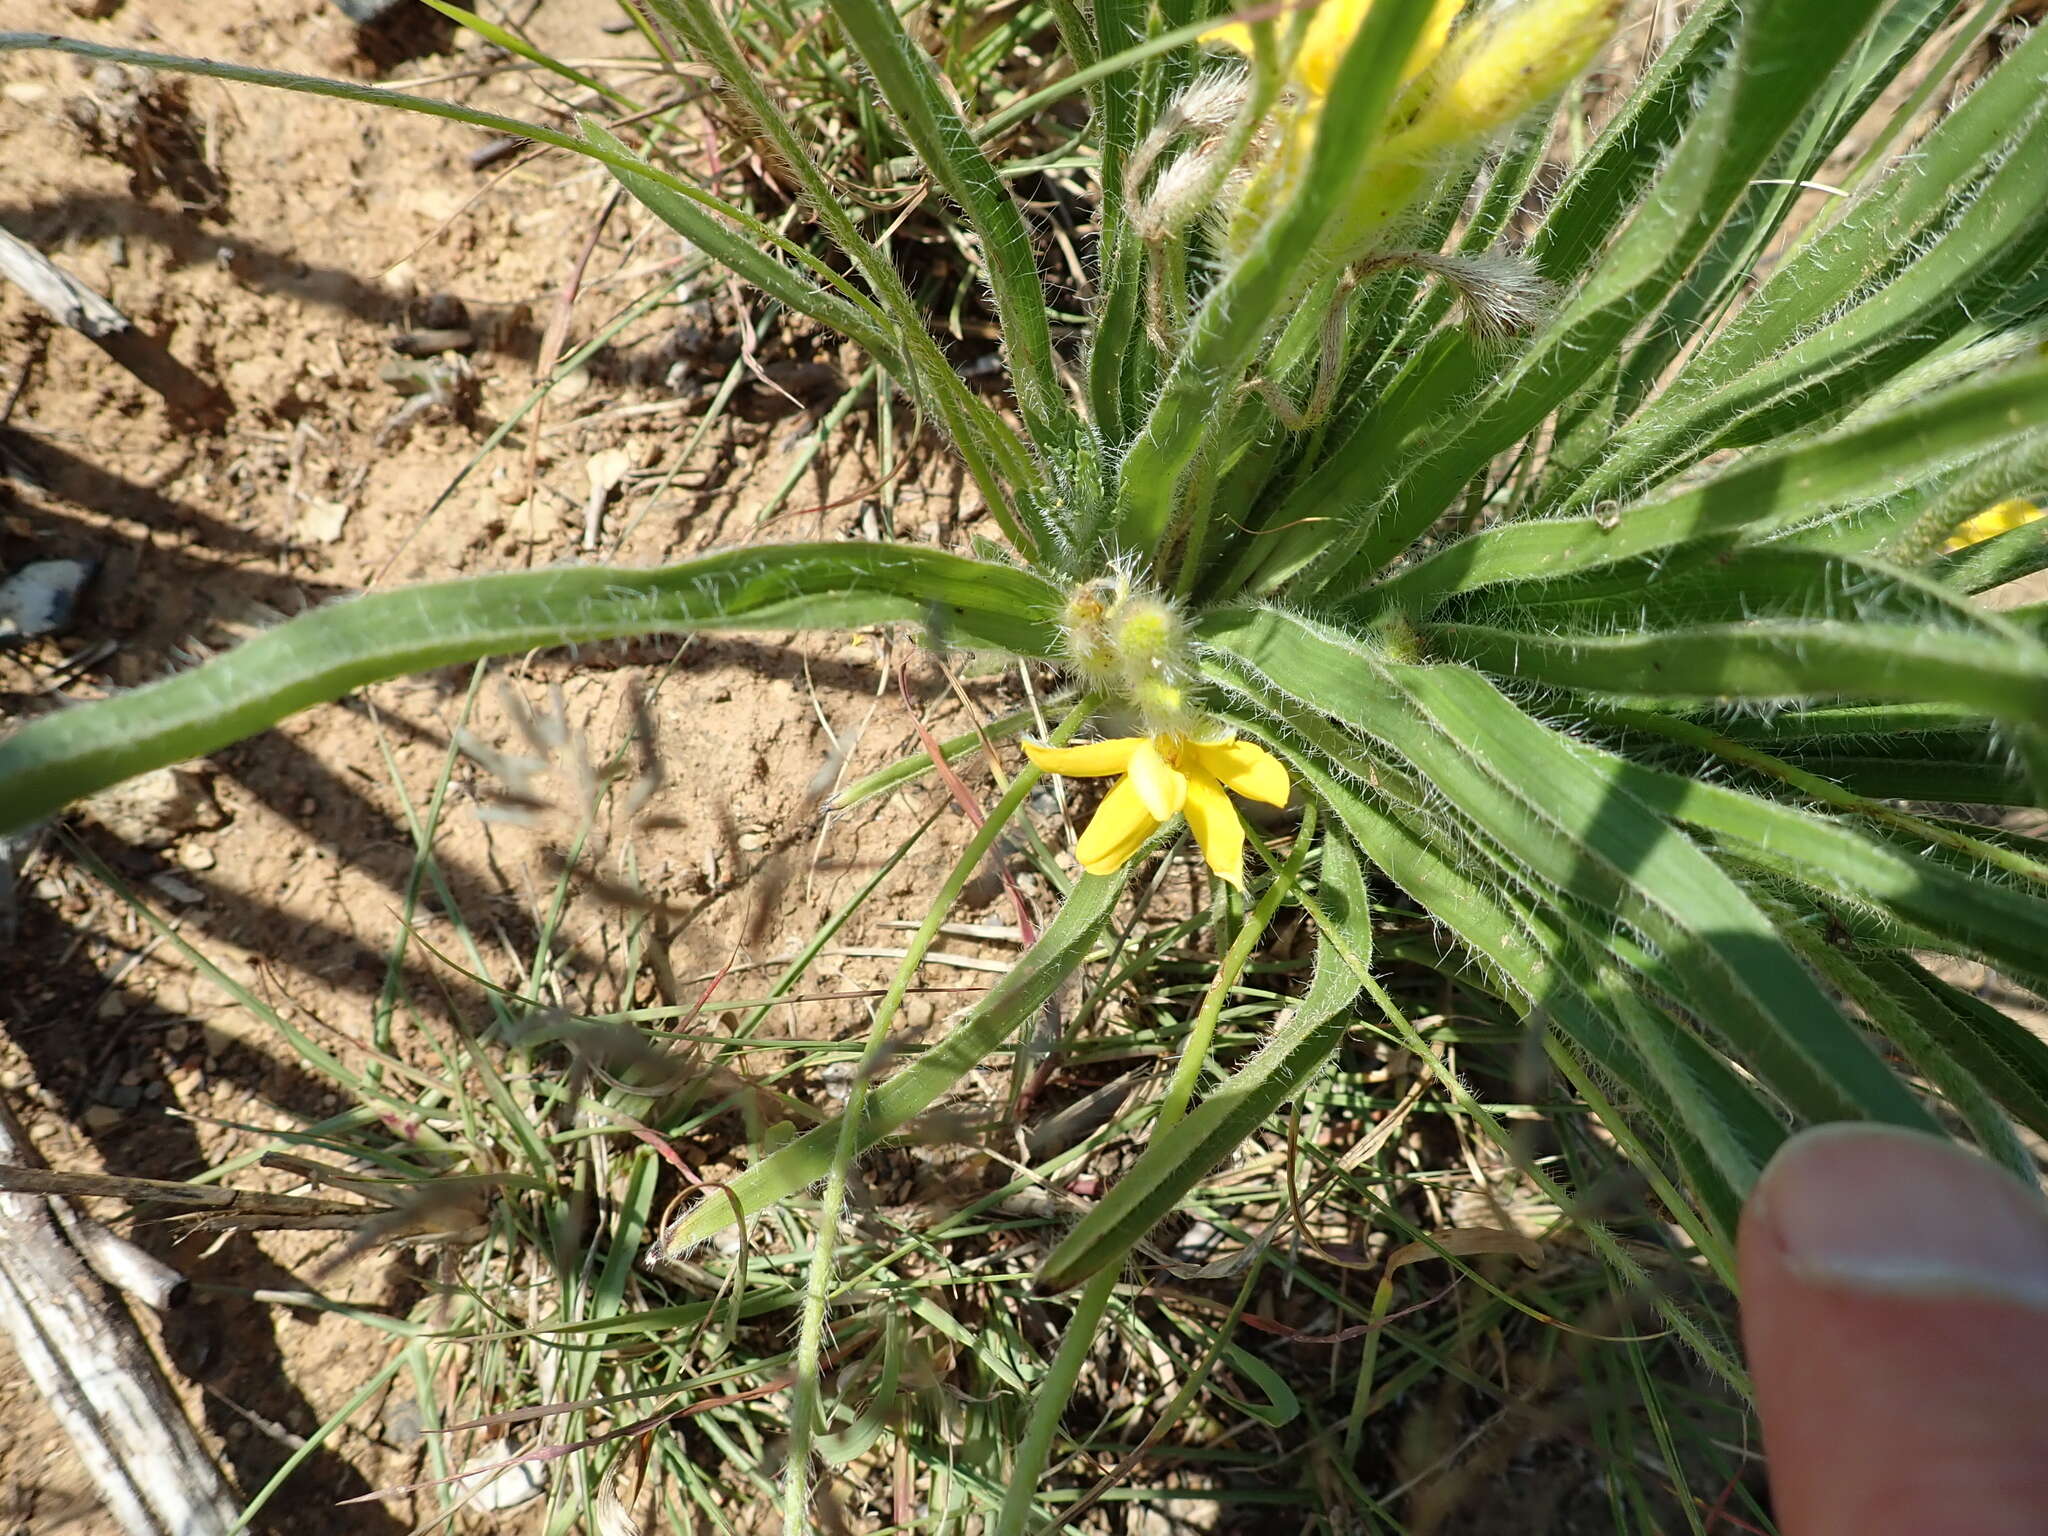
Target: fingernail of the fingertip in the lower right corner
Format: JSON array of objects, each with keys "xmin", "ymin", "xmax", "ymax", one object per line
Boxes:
[{"xmin": 1751, "ymin": 1124, "xmax": 2048, "ymax": 1311}]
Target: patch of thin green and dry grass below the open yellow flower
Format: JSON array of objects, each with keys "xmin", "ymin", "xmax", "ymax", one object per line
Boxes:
[{"xmin": 64, "ymin": 670, "xmax": 1733, "ymax": 1530}]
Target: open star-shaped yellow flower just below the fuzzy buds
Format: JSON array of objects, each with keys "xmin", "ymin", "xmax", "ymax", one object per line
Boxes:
[{"xmin": 1024, "ymin": 735, "xmax": 1290, "ymax": 889}]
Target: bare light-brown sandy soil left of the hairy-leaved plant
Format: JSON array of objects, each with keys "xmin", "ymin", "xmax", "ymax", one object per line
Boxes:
[{"xmin": 0, "ymin": 0, "xmax": 1024, "ymax": 1536}]
